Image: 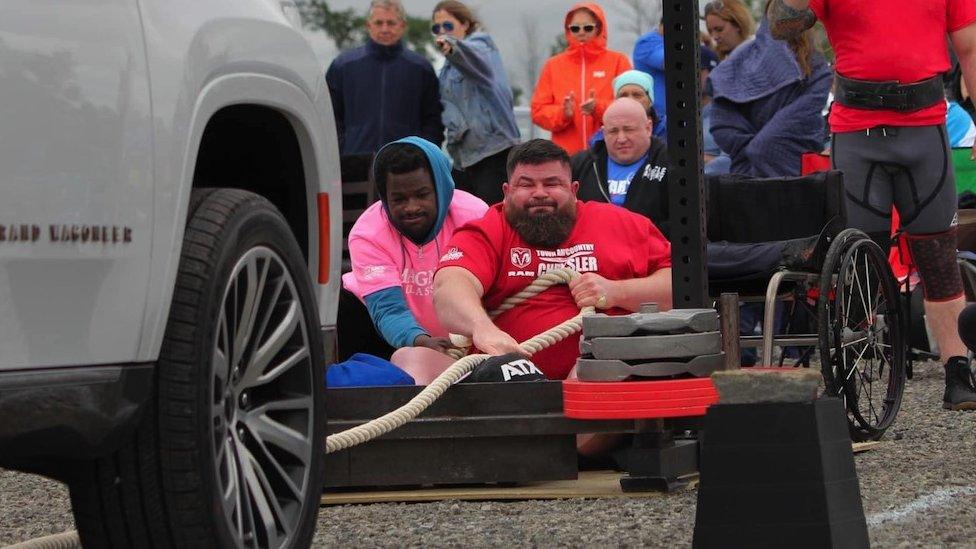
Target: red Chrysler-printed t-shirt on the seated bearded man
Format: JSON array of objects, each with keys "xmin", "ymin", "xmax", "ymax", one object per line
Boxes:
[{"xmin": 438, "ymin": 201, "xmax": 671, "ymax": 379}]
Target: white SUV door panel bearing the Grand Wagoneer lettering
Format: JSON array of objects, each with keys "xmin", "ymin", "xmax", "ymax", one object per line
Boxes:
[{"xmin": 0, "ymin": 0, "xmax": 154, "ymax": 370}]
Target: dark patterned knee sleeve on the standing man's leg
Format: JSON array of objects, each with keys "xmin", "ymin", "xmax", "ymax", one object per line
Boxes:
[{"xmin": 906, "ymin": 227, "xmax": 964, "ymax": 301}]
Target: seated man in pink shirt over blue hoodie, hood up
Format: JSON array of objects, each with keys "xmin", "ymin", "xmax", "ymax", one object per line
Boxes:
[{"xmin": 340, "ymin": 136, "xmax": 488, "ymax": 356}]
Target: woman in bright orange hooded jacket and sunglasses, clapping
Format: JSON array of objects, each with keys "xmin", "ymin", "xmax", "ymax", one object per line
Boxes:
[{"xmin": 532, "ymin": 2, "xmax": 630, "ymax": 155}]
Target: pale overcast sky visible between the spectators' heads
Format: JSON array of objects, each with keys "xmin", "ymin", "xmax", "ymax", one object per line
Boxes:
[{"xmin": 304, "ymin": 0, "xmax": 661, "ymax": 102}]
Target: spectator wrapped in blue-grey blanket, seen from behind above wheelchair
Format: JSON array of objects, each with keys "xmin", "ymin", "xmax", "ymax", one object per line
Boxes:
[{"xmin": 709, "ymin": 2, "xmax": 832, "ymax": 177}]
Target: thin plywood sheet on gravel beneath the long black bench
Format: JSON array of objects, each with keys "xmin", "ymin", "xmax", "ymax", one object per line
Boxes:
[{"xmin": 321, "ymin": 442, "xmax": 881, "ymax": 505}]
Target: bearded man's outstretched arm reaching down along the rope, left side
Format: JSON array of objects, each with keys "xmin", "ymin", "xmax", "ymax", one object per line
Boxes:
[{"xmin": 434, "ymin": 267, "xmax": 525, "ymax": 355}]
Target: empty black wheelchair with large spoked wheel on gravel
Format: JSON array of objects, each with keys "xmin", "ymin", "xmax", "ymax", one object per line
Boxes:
[{"xmin": 706, "ymin": 171, "xmax": 908, "ymax": 441}]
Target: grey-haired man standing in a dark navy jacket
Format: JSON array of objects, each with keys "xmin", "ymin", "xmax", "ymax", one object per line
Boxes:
[{"xmin": 325, "ymin": 0, "xmax": 444, "ymax": 155}]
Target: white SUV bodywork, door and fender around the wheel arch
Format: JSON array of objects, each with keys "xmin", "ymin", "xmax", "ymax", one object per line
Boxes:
[{"xmin": 0, "ymin": 0, "xmax": 342, "ymax": 370}]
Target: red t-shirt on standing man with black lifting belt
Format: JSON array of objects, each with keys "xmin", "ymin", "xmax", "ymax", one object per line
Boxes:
[{"xmin": 810, "ymin": 0, "xmax": 976, "ymax": 132}]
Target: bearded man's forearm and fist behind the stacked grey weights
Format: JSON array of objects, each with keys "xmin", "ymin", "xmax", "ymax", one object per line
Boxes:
[{"xmin": 569, "ymin": 267, "xmax": 672, "ymax": 312}]
